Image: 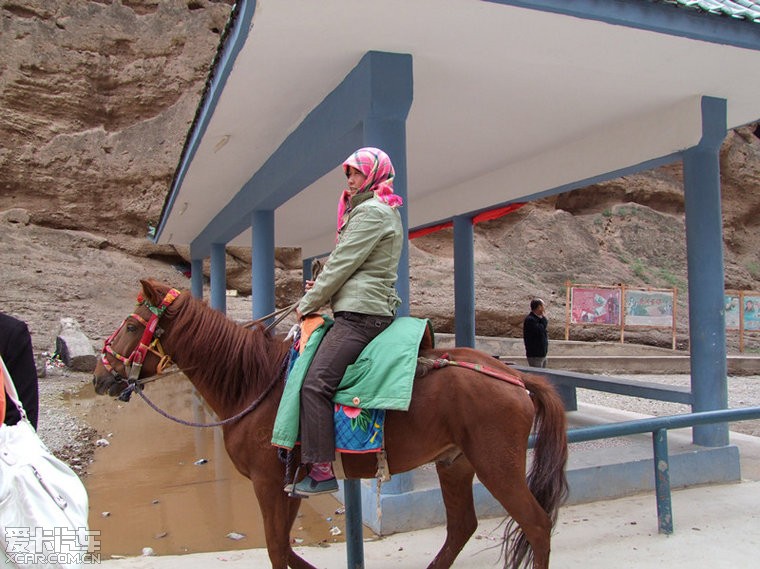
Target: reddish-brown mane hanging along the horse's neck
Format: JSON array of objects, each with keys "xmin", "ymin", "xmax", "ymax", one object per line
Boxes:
[{"xmin": 166, "ymin": 293, "xmax": 288, "ymax": 409}]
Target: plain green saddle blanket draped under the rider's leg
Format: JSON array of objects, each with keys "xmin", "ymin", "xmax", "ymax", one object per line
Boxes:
[{"xmin": 272, "ymin": 316, "xmax": 428, "ymax": 449}]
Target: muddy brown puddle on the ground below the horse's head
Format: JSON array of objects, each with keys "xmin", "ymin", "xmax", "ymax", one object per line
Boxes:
[{"xmin": 76, "ymin": 374, "xmax": 356, "ymax": 559}]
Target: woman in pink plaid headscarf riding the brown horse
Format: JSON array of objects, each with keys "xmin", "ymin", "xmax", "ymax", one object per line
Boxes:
[{"xmin": 294, "ymin": 148, "xmax": 403, "ymax": 496}]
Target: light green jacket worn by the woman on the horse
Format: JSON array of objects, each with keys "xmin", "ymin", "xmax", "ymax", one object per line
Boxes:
[{"xmin": 298, "ymin": 192, "xmax": 404, "ymax": 316}]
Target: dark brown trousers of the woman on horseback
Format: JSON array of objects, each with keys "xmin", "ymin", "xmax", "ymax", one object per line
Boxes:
[{"xmin": 301, "ymin": 312, "xmax": 393, "ymax": 464}]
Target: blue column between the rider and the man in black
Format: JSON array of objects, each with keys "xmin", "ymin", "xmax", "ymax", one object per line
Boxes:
[{"xmin": 454, "ymin": 215, "xmax": 475, "ymax": 348}]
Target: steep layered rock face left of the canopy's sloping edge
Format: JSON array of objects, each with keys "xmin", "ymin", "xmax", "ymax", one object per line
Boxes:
[{"xmin": 0, "ymin": 0, "xmax": 233, "ymax": 237}]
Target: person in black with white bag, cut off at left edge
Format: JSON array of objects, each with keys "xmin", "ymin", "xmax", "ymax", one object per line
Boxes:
[{"xmin": 0, "ymin": 312, "xmax": 39, "ymax": 429}]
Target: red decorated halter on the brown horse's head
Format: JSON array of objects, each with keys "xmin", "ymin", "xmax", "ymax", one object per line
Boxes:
[{"xmin": 100, "ymin": 288, "xmax": 180, "ymax": 383}]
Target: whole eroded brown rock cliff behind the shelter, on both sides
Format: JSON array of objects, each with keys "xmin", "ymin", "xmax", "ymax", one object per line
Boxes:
[{"xmin": 0, "ymin": 0, "xmax": 760, "ymax": 349}]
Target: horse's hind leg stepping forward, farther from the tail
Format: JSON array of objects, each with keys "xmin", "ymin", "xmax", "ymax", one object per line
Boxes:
[{"xmin": 428, "ymin": 455, "xmax": 478, "ymax": 569}]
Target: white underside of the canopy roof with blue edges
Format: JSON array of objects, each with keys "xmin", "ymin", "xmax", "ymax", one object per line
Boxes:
[{"xmin": 156, "ymin": 0, "xmax": 760, "ymax": 257}]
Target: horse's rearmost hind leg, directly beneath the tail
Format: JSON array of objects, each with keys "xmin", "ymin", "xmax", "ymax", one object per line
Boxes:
[{"xmin": 468, "ymin": 452, "xmax": 552, "ymax": 569}]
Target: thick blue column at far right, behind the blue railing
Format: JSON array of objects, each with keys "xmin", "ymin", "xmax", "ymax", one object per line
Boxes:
[{"xmin": 683, "ymin": 97, "xmax": 728, "ymax": 446}]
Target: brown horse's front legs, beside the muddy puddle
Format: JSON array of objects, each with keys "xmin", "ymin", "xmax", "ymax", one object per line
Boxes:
[{"xmin": 253, "ymin": 477, "xmax": 316, "ymax": 569}]
